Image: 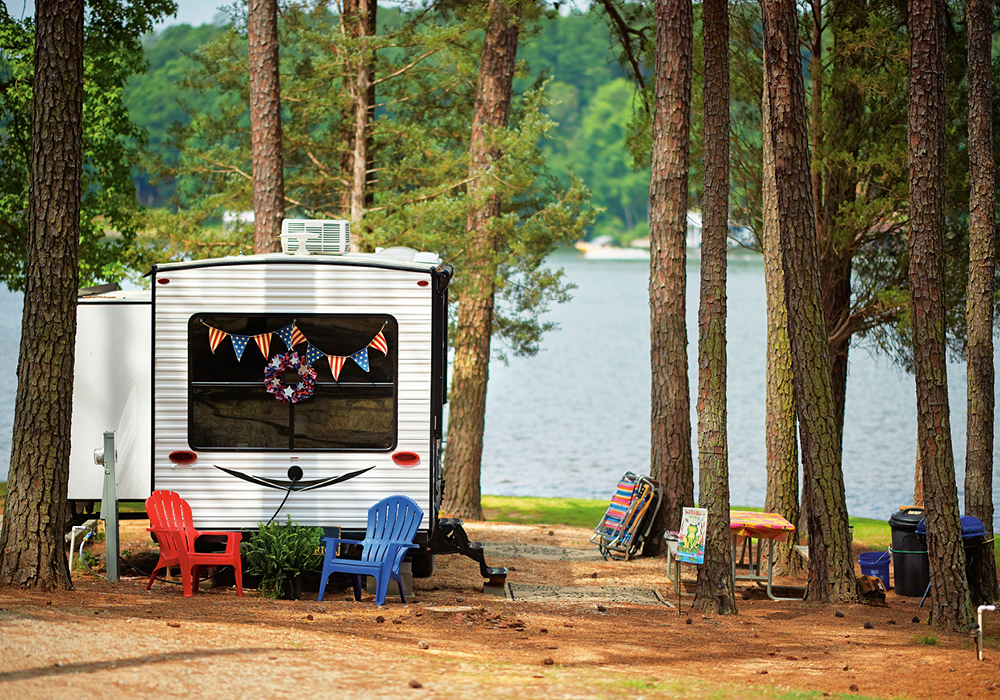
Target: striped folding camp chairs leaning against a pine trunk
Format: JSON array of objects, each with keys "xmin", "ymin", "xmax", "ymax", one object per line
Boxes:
[{"xmin": 590, "ymin": 472, "xmax": 662, "ymax": 560}]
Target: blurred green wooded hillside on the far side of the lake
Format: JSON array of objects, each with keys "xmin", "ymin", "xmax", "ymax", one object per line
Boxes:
[{"xmin": 126, "ymin": 8, "xmax": 650, "ymax": 243}]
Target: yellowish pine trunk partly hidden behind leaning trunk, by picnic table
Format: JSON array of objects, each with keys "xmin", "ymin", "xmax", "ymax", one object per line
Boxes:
[{"xmin": 760, "ymin": 47, "xmax": 803, "ymax": 576}]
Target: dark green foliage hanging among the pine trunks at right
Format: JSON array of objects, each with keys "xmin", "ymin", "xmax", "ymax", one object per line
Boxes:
[{"xmin": 730, "ymin": 1, "xmax": 1000, "ymax": 368}]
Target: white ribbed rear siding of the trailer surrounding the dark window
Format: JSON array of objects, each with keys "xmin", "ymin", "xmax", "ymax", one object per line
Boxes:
[{"xmin": 152, "ymin": 259, "xmax": 433, "ymax": 530}]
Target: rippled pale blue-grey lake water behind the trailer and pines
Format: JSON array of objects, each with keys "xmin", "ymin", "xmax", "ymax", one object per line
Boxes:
[{"xmin": 0, "ymin": 250, "xmax": 1000, "ymax": 527}]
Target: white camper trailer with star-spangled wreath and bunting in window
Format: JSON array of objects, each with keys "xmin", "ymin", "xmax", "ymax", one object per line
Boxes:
[{"xmin": 69, "ymin": 220, "xmax": 499, "ymax": 576}]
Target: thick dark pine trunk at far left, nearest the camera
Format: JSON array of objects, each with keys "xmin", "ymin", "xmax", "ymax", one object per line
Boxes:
[{"xmin": 0, "ymin": 0, "xmax": 83, "ymax": 590}]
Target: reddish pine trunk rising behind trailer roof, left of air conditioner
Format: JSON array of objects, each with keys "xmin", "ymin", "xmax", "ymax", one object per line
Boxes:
[{"xmin": 247, "ymin": 0, "xmax": 285, "ymax": 253}]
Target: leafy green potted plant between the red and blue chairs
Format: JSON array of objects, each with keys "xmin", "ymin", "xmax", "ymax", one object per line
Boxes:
[{"xmin": 243, "ymin": 515, "xmax": 323, "ymax": 600}]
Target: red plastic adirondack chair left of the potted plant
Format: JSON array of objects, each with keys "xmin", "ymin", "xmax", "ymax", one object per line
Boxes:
[{"xmin": 146, "ymin": 491, "xmax": 243, "ymax": 597}]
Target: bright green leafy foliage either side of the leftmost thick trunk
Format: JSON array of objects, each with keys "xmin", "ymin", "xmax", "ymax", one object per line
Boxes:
[{"xmin": 0, "ymin": 0, "xmax": 176, "ymax": 290}]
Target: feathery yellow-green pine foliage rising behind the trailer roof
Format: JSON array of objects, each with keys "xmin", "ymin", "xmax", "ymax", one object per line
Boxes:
[{"xmin": 153, "ymin": 6, "xmax": 592, "ymax": 357}]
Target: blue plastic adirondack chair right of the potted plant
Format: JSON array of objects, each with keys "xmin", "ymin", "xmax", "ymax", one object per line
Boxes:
[{"xmin": 316, "ymin": 496, "xmax": 424, "ymax": 605}]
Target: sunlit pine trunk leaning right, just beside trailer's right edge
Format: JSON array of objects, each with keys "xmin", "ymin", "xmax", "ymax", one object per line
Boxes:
[{"xmin": 442, "ymin": 0, "xmax": 520, "ymax": 520}]
